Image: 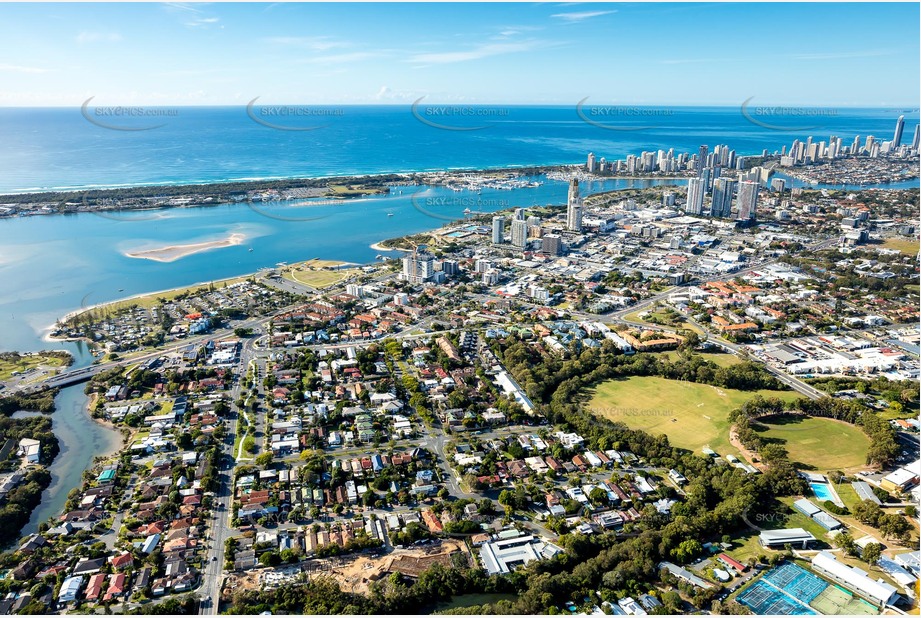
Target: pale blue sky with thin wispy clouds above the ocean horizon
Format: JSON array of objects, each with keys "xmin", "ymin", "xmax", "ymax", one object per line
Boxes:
[{"xmin": 0, "ymin": 3, "xmax": 921, "ymax": 107}]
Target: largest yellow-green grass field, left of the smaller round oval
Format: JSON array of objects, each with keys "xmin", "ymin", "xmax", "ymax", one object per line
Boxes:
[{"xmin": 588, "ymin": 377, "xmax": 799, "ymax": 455}]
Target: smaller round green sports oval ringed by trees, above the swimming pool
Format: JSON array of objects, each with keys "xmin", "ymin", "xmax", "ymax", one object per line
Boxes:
[{"xmin": 754, "ymin": 415, "xmax": 870, "ymax": 472}]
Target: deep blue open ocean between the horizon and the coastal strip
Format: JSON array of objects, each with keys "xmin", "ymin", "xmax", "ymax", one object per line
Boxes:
[{"xmin": 0, "ymin": 101, "xmax": 918, "ymax": 192}]
